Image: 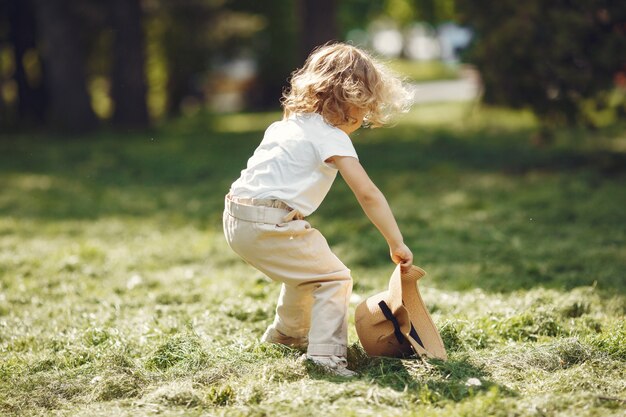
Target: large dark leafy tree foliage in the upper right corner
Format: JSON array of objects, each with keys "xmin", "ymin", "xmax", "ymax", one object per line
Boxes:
[{"xmin": 458, "ymin": 0, "xmax": 626, "ymax": 129}]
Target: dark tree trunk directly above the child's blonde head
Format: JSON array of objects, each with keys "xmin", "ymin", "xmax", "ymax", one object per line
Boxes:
[{"xmin": 300, "ymin": 0, "xmax": 339, "ymax": 61}]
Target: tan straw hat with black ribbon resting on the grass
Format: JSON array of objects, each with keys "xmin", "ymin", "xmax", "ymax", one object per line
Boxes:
[{"xmin": 355, "ymin": 265, "xmax": 447, "ymax": 359}]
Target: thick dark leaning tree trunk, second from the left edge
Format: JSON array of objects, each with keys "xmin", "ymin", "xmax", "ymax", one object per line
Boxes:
[{"xmin": 33, "ymin": 0, "xmax": 97, "ymax": 132}]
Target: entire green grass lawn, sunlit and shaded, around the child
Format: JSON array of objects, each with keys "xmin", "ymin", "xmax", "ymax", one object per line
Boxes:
[{"xmin": 0, "ymin": 104, "xmax": 626, "ymax": 416}]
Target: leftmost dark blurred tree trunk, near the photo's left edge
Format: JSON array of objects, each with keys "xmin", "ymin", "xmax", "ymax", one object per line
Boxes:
[{"xmin": 8, "ymin": 0, "xmax": 45, "ymax": 125}]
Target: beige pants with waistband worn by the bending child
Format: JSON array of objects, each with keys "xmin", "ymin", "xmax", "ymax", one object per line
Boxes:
[{"xmin": 224, "ymin": 196, "xmax": 352, "ymax": 356}]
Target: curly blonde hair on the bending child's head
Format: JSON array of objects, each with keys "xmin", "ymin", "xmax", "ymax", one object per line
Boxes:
[{"xmin": 281, "ymin": 43, "xmax": 411, "ymax": 127}]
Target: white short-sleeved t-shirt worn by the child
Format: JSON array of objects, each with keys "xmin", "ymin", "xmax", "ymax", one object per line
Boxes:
[{"xmin": 230, "ymin": 113, "xmax": 358, "ymax": 216}]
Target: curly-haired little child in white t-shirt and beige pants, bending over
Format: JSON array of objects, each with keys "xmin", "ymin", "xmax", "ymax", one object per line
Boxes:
[{"xmin": 224, "ymin": 43, "xmax": 413, "ymax": 376}]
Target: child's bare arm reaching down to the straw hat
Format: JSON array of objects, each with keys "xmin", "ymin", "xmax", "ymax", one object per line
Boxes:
[{"xmin": 327, "ymin": 156, "xmax": 413, "ymax": 272}]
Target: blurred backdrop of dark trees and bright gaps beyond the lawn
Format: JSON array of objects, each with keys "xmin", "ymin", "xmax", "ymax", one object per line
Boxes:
[{"xmin": 0, "ymin": 0, "xmax": 626, "ymax": 132}]
